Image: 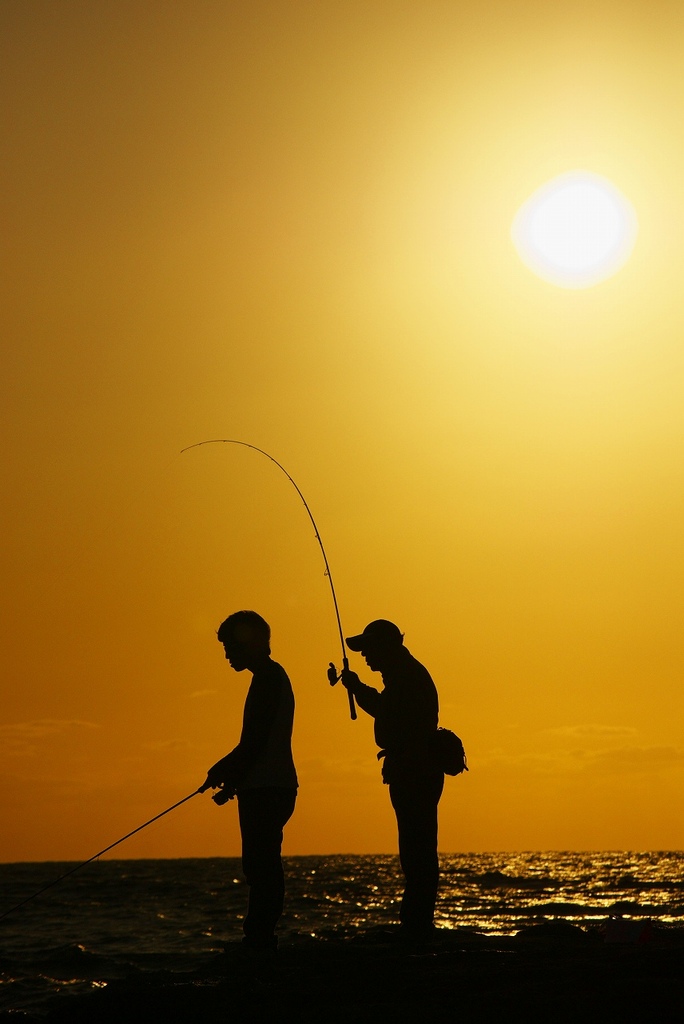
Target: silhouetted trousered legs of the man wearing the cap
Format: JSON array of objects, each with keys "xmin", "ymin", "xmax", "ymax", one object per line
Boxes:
[{"xmin": 389, "ymin": 775, "xmax": 444, "ymax": 936}]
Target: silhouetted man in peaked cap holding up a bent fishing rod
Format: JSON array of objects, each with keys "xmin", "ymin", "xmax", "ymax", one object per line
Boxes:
[{"xmin": 341, "ymin": 618, "xmax": 444, "ymax": 939}]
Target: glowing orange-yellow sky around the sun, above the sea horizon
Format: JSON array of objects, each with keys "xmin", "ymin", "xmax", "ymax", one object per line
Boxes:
[{"xmin": 0, "ymin": 0, "xmax": 684, "ymax": 860}]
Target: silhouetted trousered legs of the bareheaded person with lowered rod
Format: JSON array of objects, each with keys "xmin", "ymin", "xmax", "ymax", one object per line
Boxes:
[{"xmin": 238, "ymin": 786, "xmax": 297, "ymax": 949}]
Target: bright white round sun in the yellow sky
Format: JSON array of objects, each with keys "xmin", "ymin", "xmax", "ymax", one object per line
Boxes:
[{"xmin": 511, "ymin": 171, "xmax": 638, "ymax": 288}]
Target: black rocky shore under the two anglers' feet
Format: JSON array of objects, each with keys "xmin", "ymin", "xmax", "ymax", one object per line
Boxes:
[{"xmin": 13, "ymin": 923, "xmax": 684, "ymax": 1024}]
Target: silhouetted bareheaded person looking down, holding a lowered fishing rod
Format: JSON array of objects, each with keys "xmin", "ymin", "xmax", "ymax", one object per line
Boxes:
[{"xmin": 197, "ymin": 611, "xmax": 297, "ymax": 950}]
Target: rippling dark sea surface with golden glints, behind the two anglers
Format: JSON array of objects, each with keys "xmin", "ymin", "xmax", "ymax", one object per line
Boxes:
[{"xmin": 0, "ymin": 851, "xmax": 684, "ymax": 1020}]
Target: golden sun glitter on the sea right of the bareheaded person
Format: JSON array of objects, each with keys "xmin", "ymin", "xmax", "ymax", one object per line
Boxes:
[{"xmin": 286, "ymin": 852, "xmax": 684, "ymax": 935}]
